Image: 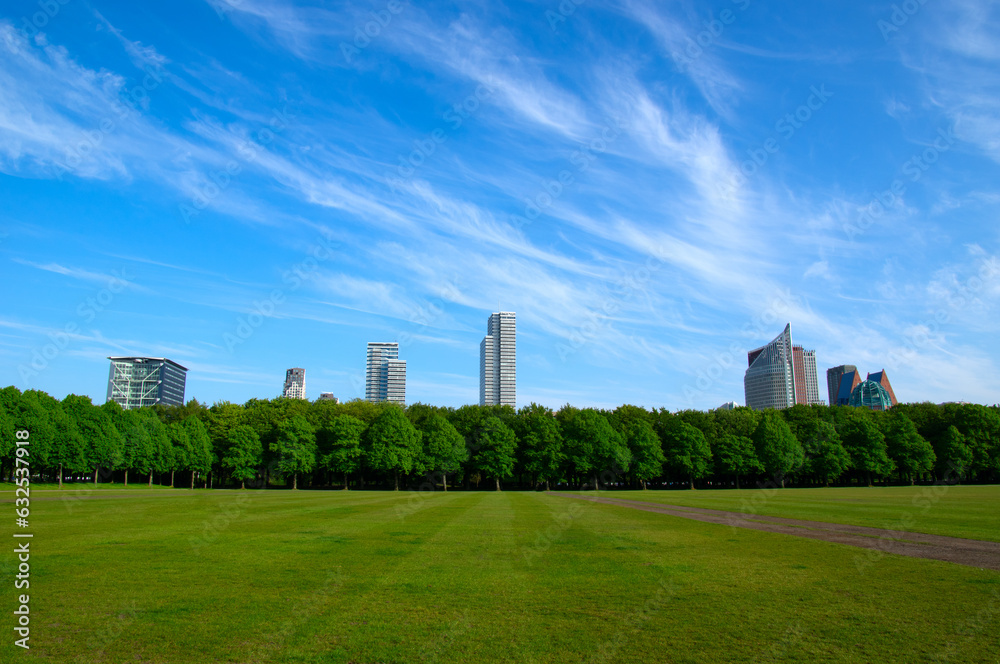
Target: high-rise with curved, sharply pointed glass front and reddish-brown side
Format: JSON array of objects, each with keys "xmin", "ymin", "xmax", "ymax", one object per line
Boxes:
[{"xmin": 743, "ymin": 324, "xmax": 822, "ymax": 410}]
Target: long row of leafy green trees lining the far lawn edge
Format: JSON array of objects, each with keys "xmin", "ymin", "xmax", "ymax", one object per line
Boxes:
[{"xmin": 0, "ymin": 387, "xmax": 1000, "ymax": 490}]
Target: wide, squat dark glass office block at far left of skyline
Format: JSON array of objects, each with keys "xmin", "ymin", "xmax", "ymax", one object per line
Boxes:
[{"xmin": 107, "ymin": 357, "xmax": 187, "ymax": 409}]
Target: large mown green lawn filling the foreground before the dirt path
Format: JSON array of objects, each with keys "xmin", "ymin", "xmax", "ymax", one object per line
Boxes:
[{"xmin": 0, "ymin": 485, "xmax": 1000, "ymax": 664}]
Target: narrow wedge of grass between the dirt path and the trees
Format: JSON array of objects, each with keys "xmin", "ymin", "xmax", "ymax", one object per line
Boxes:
[{"xmin": 601, "ymin": 485, "xmax": 1000, "ymax": 544}]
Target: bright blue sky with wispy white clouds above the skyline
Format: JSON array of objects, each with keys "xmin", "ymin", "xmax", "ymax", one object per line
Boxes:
[{"xmin": 0, "ymin": 0, "xmax": 1000, "ymax": 410}]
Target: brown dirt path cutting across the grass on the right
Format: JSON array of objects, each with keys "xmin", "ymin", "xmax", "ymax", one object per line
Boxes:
[{"xmin": 552, "ymin": 492, "xmax": 1000, "ymax": 571}]
